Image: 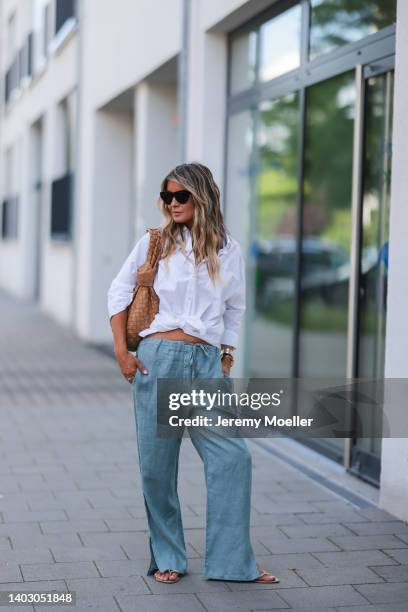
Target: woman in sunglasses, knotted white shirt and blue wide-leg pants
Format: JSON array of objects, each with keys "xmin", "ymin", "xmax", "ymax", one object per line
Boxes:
[{"xmin": 108, "ymin": 163, "xmax": 279, "ymax": 583}]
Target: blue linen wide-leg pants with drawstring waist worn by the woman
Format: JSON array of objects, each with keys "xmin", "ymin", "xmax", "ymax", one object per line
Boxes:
[{"xmin": 132, "ymin": 337, "xmax": 260, "ymax": 581}]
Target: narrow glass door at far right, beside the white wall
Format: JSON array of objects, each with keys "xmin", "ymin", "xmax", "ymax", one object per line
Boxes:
[{"xmin": 349, "ymin": 58, "xmax": 394, "ymax": 485}]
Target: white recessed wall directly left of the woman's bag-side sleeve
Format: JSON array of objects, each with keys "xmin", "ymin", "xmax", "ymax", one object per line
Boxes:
[{"xmin": 87, "ymin": 111, "xmax": 133, "ymax": 340}]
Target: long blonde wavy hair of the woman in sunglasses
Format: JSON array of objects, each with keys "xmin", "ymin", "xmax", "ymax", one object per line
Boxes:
[{"xmin": 157, "ymin": 162, "xmax": 229, "ymax": 284}]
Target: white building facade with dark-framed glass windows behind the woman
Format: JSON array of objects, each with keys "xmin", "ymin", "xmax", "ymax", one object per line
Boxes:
[{"xmin": 0, "ymin": 0, "xmax": 408, "ymax": 520}]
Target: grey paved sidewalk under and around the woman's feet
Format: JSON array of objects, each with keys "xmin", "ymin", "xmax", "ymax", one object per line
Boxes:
[{"xmin": 0, "ymin": 294, "xmax": 408, "ymax": 612}]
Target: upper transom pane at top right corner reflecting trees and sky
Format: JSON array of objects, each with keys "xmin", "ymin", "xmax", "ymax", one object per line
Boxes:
[{"xmin": 309, "ymin": 0, "xmax": 396, "ymax": 60}]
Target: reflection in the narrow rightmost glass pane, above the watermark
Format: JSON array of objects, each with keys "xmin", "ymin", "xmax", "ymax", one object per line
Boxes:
[{"xmin": 358, "ymin": 72, "xmax": 394, "ymax": 377}]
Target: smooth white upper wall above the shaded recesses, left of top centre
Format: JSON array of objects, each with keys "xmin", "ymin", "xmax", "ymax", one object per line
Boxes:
[{"xmin": 82, "ymin": 0, "xmax": 182, "ymax": 107}]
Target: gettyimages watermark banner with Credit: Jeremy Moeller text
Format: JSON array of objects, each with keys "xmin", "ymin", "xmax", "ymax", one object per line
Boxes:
[{"xmin": 157, "ymin": 377, "xmax": 408, "ymax": 438}]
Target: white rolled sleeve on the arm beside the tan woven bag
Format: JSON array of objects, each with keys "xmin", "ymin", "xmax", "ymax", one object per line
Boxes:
[{"xmin": 107, "ymin": 232, "xmax": 149, "ymax": 321}]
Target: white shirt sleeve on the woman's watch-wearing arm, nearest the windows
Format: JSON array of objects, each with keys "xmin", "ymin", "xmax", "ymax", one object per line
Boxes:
[{"xmin": 221, "ymin": 243, "xmax": 246, "ymax": 348}]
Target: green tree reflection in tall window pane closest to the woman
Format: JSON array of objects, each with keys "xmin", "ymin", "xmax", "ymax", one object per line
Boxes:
[{"xmin": 251, "ymin": 93, "xmax": 299, "ymax": 377}]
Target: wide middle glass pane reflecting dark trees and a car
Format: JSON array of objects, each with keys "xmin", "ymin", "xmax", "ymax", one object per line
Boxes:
[{"xmin": 299, "ymin": 71, "xmax": 355, "ymax": 378}]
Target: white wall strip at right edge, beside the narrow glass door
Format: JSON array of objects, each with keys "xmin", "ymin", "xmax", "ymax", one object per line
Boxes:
[{"xmin": 380, "ymin": 0, "xmax": 408, "ymax": 520}]
